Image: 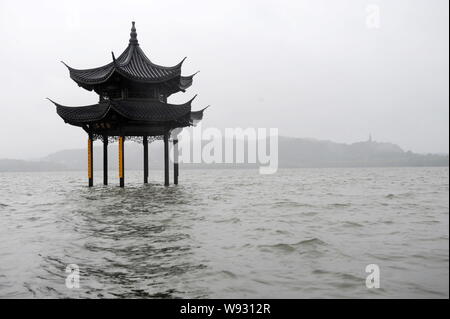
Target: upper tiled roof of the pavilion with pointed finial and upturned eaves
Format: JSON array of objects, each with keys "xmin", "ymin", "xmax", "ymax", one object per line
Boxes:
[{"xmin": 63, "ymin": 22, "xmax": 194, "ymax": 91}]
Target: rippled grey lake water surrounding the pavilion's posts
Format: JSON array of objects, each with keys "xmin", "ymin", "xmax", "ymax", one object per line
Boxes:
[{"xmin": 0, "ymin": 168, "xmax": 449, "ymax": 298}]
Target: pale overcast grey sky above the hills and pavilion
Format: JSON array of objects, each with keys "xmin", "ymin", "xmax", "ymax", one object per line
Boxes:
[{"xmin": 0, "ymin": 0, "xmax": 449, "ymax": 158}]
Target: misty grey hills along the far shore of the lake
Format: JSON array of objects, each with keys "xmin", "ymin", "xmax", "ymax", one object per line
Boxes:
[{"xmin": 0, "ymin": 137, "xmax": 449, "ymax": 171}]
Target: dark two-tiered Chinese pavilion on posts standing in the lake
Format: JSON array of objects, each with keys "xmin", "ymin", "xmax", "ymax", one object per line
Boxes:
[{"xmin": 51, "ymin": 22, "xmax": 205, "ymax": 187}]
